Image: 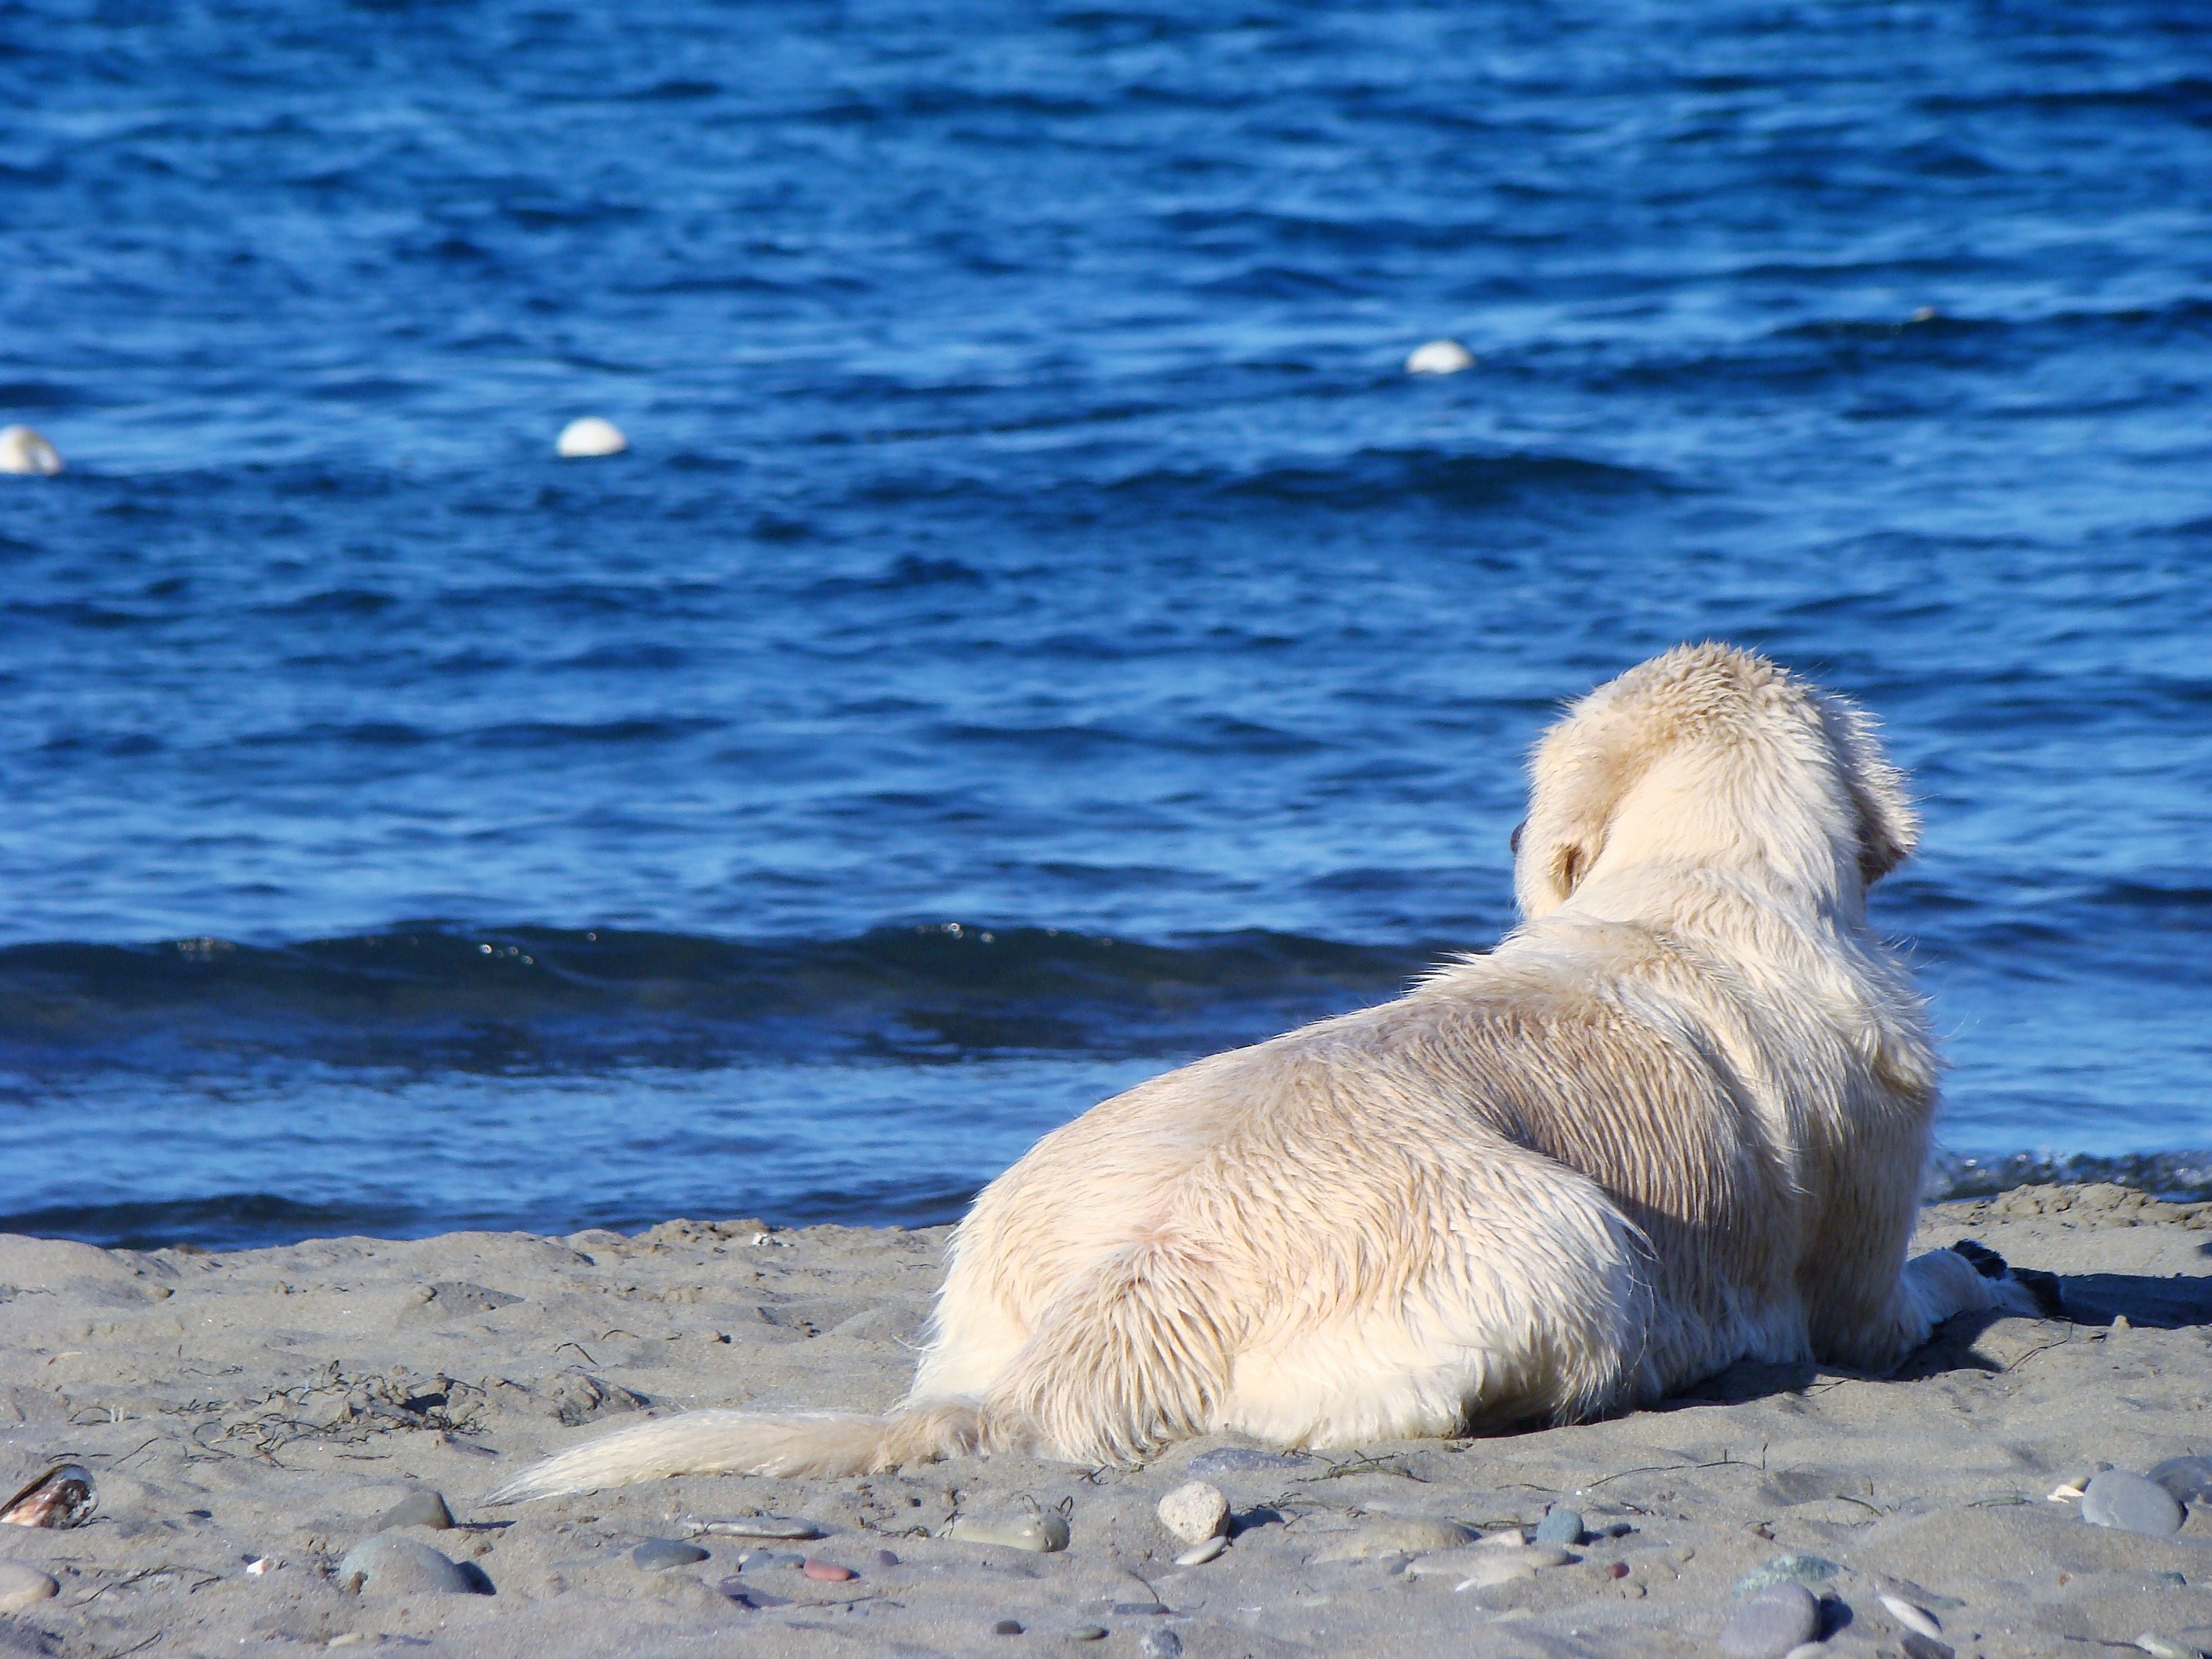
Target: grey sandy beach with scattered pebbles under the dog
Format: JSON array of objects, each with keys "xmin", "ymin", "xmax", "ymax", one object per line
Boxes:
[{"xmin": 0, "ymin": 1186, "xmax": 2212, "ymax": 1659}]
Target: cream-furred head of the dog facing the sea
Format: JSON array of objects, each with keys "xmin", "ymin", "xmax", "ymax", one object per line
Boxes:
[{"xmin": 1513, "ymin": 644, "xmax": 1920, "ymax": 920}]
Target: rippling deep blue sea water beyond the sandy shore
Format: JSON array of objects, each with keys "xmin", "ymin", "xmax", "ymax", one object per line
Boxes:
[{"xmin": 0, "ymin": 0, "xmax": 2212, "ymax": 1243}]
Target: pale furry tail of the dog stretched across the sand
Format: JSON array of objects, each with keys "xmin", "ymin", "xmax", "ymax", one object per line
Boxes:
[{"xmin": 485, "ymin": 1400, "xmax": 984, "ymax": 1504}]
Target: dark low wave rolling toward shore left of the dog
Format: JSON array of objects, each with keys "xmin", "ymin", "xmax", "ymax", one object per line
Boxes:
[{"xmin": 0, "ymin": 922, "xmax": 1447, "ymax": 1075}]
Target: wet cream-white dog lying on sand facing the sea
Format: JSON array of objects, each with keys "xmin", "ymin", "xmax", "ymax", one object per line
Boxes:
[{"xmin": 493, "ymin": 644, "xmax": 2037, "ymax": 1502}]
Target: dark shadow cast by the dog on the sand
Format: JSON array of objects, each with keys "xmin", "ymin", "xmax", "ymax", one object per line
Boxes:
[{"xmin": 1659, "ymin": 1274, "xmax": 2212, "ymax": 1411}]
